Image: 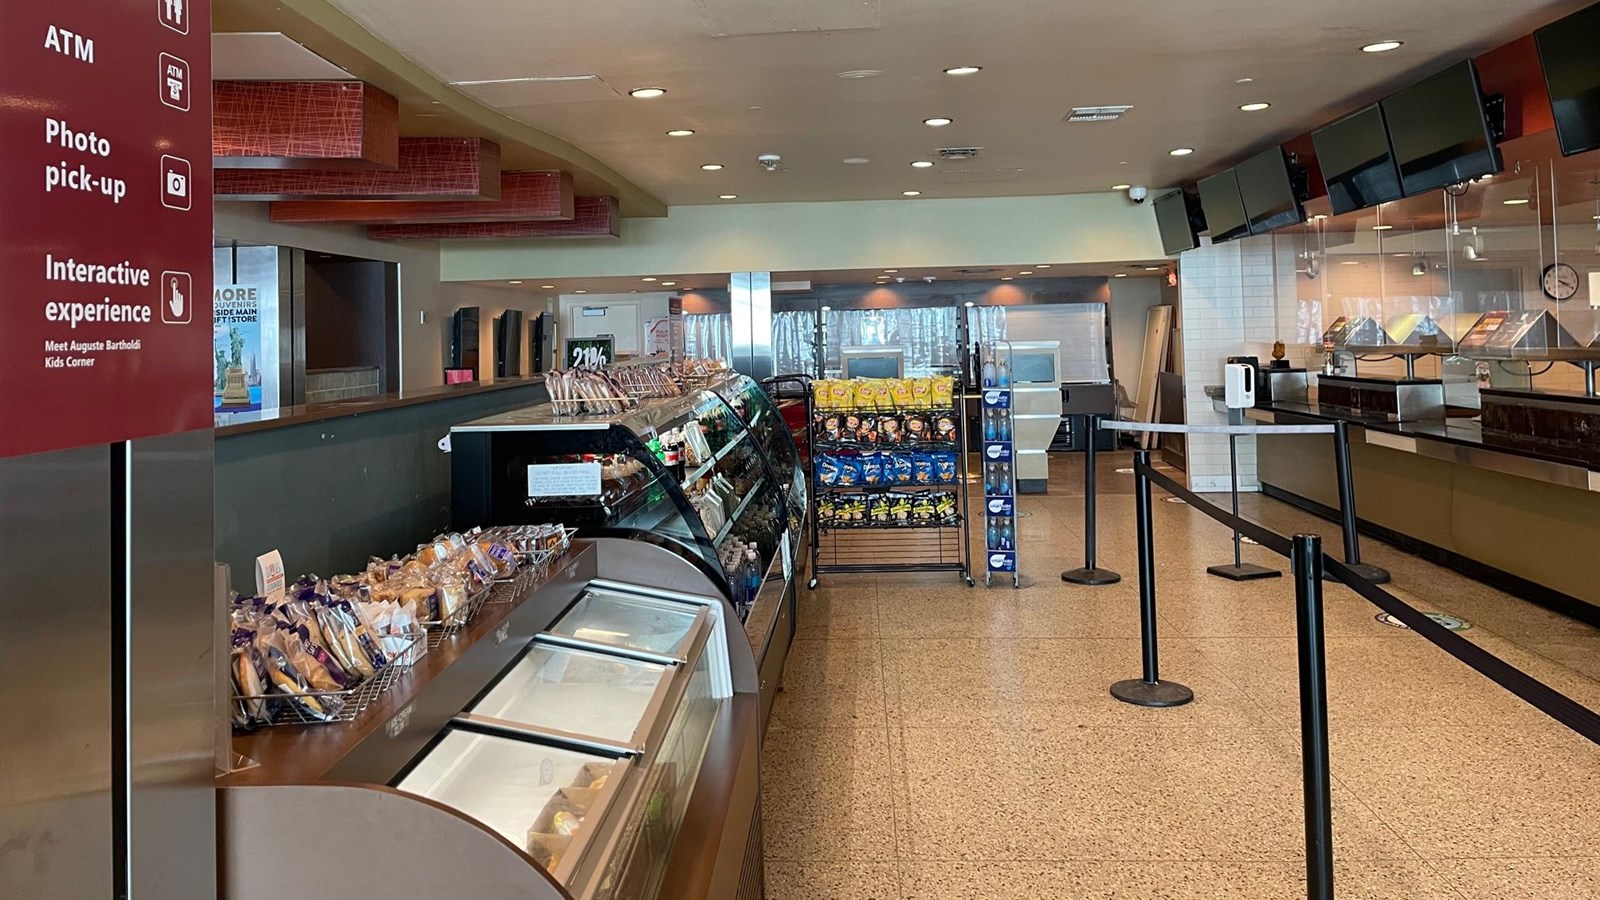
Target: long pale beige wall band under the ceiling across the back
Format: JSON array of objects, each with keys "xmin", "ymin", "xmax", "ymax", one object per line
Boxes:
[{"xmin": 440, "ymin": 194, "xmax": 1165, "ymax": 280}]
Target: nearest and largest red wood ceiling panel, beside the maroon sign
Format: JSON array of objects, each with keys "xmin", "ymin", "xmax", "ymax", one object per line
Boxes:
[{"xmin": 211, "ymin": 82, "xmax": 400, "ymax": 168}]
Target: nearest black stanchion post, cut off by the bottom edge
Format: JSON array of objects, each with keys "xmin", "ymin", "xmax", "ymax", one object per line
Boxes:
[{"xmin": 1290, "ymin": 535, "xmax": 1333, "ymax": 900}]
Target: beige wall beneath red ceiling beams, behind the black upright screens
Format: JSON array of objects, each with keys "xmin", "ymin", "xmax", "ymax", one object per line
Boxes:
[{"xmin": 214, "ymin": 202, "xmax": 555, "ymax": 389}]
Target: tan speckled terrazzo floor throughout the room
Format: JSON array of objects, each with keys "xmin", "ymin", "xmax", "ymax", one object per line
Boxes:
[{"xmin": 762, "ymin": 453, "xmax": 1600, "ymax": 900}]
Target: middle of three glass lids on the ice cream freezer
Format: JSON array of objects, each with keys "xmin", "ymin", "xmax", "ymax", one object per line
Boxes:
[{"xmin": 467, "ymin": 642, "xmax": 672, "ymax": 746}]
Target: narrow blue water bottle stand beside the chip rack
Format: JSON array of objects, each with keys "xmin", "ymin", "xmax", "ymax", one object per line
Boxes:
[{"xmin": 978, "ymin": 341, "xmax": 1022, "ymax": 588}]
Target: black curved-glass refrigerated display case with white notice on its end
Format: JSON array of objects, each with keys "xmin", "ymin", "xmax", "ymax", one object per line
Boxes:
[{"xmin": 451, "ymin": 376, "xmax": 805, "ymax": 618}]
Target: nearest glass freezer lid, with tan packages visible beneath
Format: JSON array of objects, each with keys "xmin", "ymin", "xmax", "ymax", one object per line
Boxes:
[{"xmin": 395, "ymin": 727, "xmax": 626, "ymax": 874}]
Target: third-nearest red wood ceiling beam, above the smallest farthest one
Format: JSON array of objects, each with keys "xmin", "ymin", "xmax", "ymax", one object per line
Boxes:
[{"xmin": 272, "ymin": 170, "xmax": 573, "ymax": 224}]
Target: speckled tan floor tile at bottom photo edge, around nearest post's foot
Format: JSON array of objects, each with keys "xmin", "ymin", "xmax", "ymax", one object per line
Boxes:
[{"xmin": 901, "ymin": 860, "xmax": 1462, "ymax": 900}]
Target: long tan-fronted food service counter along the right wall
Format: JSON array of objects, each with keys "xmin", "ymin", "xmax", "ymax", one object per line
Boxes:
[{"xmin": 1250, "ymin": 404, "xmax": 1600, "ymax": 625}]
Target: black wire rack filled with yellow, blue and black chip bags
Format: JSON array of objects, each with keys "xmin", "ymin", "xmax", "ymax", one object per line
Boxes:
[{"xmin": 806, "ymin": 376, "xmax": 974, "ymax": 589}]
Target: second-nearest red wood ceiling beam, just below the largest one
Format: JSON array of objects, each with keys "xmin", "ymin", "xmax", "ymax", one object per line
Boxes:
[{"xmin": 216, "ymin": 138, "xmax": 501, "ymax": 200}]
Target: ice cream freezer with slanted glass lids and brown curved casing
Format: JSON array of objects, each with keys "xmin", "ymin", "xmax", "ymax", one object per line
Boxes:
[{"xmin": 219, "ymin": 535, "xmax": 762, "ymax": 900}]
